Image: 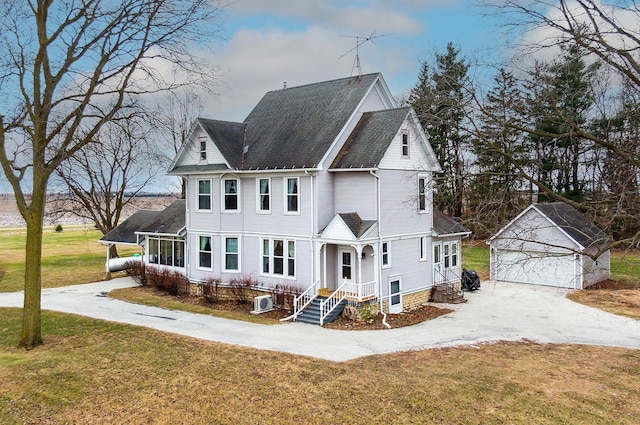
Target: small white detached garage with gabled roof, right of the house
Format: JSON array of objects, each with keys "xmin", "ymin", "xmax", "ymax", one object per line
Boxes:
[{"xmin": 487, "ymin": 202, "xmax": 610, "ymax": 289}]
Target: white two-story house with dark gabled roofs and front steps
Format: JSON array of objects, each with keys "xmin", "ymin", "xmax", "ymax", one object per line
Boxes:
[{"xmin": 102, "ymin": 73, "xmax": 468, "ymax": 324}]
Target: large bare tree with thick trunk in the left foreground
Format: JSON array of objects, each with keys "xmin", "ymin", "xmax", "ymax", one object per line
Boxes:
[{"xmin": 0, "ymin": 0, "xmax": 220, "ymax": 348}]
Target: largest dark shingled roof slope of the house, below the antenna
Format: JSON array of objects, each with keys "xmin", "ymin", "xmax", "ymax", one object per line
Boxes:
[{"xmin": 242, "ymin": 73, "xmax": 379, "ymax": 170}]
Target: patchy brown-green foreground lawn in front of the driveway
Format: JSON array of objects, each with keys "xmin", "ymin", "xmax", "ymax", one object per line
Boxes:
[{"xmin": 0, "ymin": 309, "xmax": 640, "ymax": 424}]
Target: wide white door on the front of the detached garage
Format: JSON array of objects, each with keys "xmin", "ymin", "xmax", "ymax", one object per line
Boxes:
[{"xmin": 494, "ymin": 250, "xmax": 577, "ymax": 288}]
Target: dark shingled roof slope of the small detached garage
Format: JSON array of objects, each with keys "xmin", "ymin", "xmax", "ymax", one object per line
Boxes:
[{"xmin": 534, "ymin": 202, "xmax": 610, "ymax": 248}]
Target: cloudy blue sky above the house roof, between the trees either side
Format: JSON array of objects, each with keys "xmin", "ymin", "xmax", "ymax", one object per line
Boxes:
[{"xmin": 203, "ymin": 0, "xmax": 499, "ymax": 121}]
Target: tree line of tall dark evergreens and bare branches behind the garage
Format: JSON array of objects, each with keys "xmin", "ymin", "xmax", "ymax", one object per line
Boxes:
[{"xmin": 407, "ymin": 1, "xmax": 640, "ymax": 252}]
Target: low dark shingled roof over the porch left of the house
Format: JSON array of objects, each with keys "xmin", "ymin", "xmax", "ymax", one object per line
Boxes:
[{"xmin": 100, "ymin": 199, "xmax": 186, "ymax": 244}]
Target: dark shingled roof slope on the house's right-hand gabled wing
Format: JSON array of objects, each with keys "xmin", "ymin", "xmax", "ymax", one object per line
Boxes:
[{"xmin": 330, "ymin": 107, "xmax": 411, "ymax": 169}]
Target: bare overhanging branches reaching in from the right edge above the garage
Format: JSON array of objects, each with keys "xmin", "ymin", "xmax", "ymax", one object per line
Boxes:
[{"xmin": 480, "ymin": 0, "xmax": 640, "ymax": 246}]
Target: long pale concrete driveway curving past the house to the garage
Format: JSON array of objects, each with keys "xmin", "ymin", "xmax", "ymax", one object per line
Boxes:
[{"xmin": 0, "ymin": 278, "xmax": 640, "ymax": 361}]
